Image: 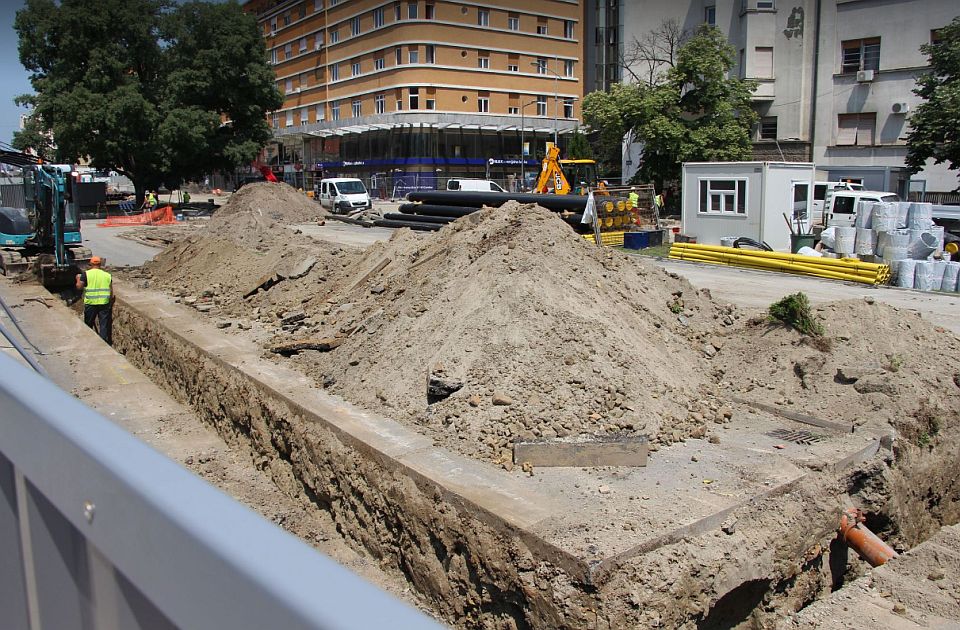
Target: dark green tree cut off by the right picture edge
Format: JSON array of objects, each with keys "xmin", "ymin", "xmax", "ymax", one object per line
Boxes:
[{"xmin": 906, "ymin": 17, "xmax": 960, "ymax": 190}]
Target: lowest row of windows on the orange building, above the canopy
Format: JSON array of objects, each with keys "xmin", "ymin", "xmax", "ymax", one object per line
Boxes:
[{"xmin": 272, "ymin": 92, "xmax": 574, "ymax": 128}]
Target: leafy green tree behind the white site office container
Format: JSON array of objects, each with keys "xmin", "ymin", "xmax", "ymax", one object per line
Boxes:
[{"xmin": 583, "ymin": 25, "xmax": 757, "ymax": 189}]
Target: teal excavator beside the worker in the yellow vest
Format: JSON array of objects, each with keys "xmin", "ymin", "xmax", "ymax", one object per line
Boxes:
[{"xmin": 0, "ymin": 150, "xmax": 91, "ymax": 289}]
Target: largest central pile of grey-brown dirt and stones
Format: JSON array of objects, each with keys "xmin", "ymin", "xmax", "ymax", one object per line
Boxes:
[{"xmin": 278, "ymin": 203, "xmax": 737, "ymax": 462}]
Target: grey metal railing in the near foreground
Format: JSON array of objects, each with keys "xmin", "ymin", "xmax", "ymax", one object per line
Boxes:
[{"xmin": 0, "ymin": 353, "xmax": 439, "ymax": 630}]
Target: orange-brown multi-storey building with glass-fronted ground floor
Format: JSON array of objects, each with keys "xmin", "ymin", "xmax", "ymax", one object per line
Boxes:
[{"xmin": 243, "ymin": 0, "xmax": 584, "ymax": 195}]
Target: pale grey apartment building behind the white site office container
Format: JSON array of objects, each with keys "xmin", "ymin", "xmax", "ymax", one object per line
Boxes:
[{"xmin": 620, "ymin": 0, "xmax": 960, "ymax": 196}]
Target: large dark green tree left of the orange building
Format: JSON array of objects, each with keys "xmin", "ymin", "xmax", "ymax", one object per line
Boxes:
[{"xmin": 14, "ymin": 0, "xmax": 282, "ymax": 199}]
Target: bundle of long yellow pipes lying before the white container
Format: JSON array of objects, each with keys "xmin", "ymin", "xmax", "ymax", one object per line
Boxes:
[{"xmin": 670, "ymin": 243, "xmax": 890, "ymax": 284}]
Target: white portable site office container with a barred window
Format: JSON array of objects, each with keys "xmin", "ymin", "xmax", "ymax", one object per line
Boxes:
[{"xmin": 681, "ymin": 162, "xmax": 816, "ymax": 251}]
